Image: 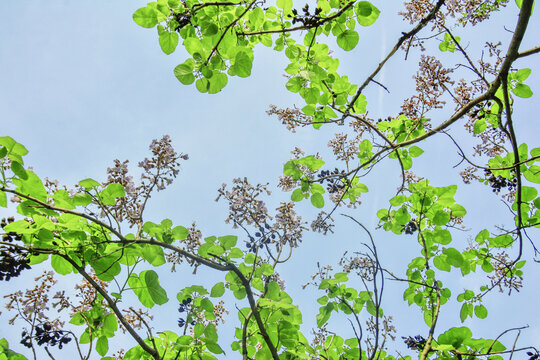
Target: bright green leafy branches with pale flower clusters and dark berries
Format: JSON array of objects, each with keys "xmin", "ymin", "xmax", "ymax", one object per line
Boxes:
[{"xmin": 0, "ymin": 0, "xmax": 540, "ymax": 360}]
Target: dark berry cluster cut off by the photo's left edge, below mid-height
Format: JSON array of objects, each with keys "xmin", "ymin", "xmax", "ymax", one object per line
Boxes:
[{"xmin": 0, "ymin": 217, "xmax": 30, "ymax": 281}]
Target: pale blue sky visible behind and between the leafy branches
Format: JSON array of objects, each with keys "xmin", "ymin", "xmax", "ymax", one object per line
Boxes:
[{"xmin": 0, "ymin": 0, "xmax": 540, "ymax": 359}]
